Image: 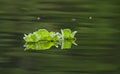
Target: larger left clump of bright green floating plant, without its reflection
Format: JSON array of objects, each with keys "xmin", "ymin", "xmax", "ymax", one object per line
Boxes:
[{"xmin": 24, "ymin": 29, "xmax": 58, "ymax": 42}]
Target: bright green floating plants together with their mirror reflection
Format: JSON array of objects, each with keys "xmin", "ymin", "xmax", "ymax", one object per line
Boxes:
[{"xmin": 23, "ymin": 29, "xmax": 77, "ymax": 50}]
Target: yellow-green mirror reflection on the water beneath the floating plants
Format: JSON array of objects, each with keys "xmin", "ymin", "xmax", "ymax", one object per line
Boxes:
[{"xmin": 24, "ymin": 40, "xmax": 77, "ymax": 50}]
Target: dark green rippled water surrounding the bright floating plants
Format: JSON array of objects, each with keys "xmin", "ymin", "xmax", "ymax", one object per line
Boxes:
[{"xmin": 0, "ymin": 0, "xmax": 120, "ymax": 74}]
